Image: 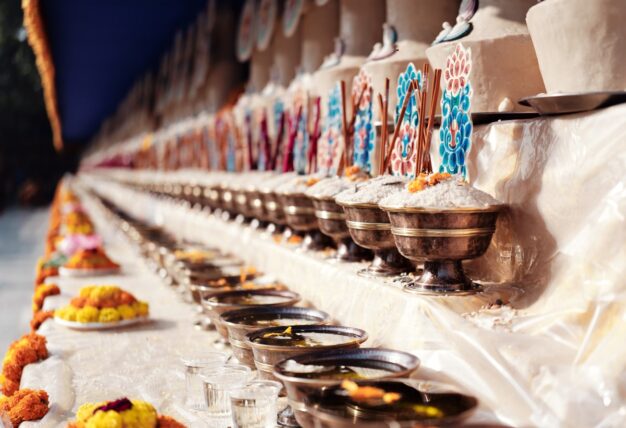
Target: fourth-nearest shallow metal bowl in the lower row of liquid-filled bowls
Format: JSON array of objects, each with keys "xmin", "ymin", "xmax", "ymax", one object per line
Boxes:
[{"xmin": 221, "ymin": 307, "xmax": 331, "ymax": 369}]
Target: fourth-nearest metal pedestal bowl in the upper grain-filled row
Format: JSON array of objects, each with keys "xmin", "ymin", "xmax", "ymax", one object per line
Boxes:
[{"xmin": 278, "ymin": 193, "xmax": 332, "ymax": 251}]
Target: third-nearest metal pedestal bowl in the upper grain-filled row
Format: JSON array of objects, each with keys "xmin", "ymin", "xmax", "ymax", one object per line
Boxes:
[{"xmin": 310, "ymin": 196, "xmax": 371, "ymax": 262}]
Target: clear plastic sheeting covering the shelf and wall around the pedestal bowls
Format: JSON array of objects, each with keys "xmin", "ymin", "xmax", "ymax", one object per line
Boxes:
[{"xmin": 68, "ymin": 106, "xmax": 626, "ymax": 427}]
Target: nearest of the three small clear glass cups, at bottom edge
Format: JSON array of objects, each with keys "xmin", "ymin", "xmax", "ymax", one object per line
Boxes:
[{"xmin": 230, "ymin": 380, "xmax": 282, "ymax": 428}]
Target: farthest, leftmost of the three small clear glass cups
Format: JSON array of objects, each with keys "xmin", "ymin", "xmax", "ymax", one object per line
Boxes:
[{"xmin": 181, "ymin": 351, "xmax": 228, "ymax": 410}]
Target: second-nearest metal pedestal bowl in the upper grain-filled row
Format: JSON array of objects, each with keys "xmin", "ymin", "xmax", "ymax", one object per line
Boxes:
[{"xmin": 338, "ymin": 203, "xmax": 413, "ymax": 277}]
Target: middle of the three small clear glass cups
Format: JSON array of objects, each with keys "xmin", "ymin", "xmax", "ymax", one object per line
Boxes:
[{"xmin": 200, "ymin": 365, "xmax": 254, "ymax": 418}]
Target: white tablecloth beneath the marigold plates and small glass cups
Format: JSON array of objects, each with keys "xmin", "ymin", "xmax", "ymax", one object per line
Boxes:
[{"xmin": 21, "ymin": 191, "xmax": 227, "ymax": 428}]
